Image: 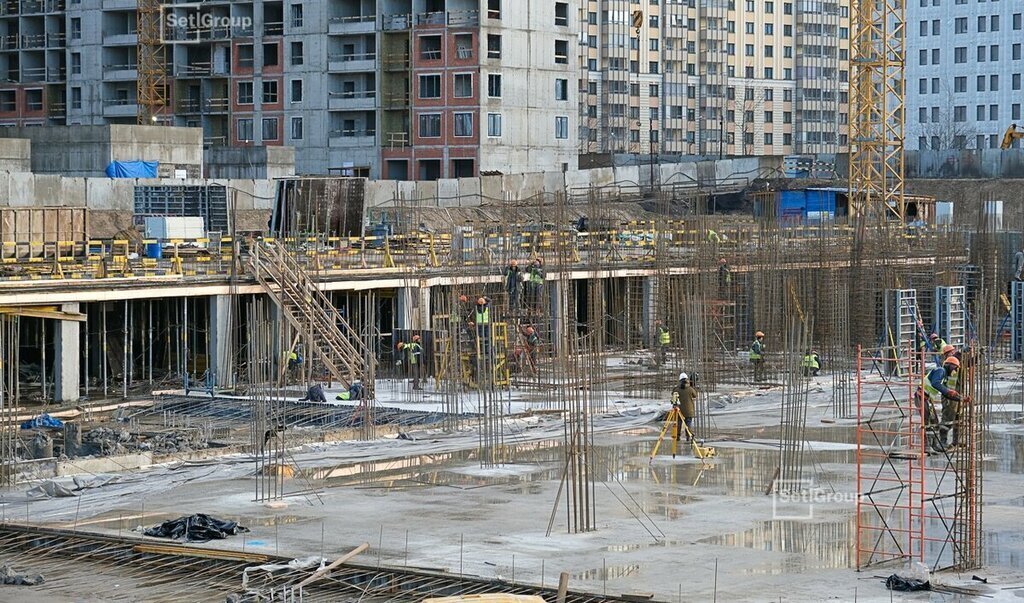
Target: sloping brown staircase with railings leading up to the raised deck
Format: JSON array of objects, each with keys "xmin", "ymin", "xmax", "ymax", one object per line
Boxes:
[{"xmin": 250, "ymin": 242, "xmax": 374, "ymax": 386}]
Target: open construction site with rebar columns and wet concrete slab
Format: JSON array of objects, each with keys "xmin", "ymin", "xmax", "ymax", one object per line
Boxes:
[{"xmin": 0, "ymin": 140, "xmax": 1024, "ymax": 601}]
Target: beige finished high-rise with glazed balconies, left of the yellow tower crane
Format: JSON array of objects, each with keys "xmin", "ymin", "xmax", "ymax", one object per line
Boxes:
[{"xmin": 580, "ymin": 0, "xmax": 850, "ymax": 156}]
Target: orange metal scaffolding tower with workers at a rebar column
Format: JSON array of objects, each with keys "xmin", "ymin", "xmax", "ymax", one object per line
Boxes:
[{"xmin": 856, "ymin": 347, "xmax": 982, "ymax": 570}]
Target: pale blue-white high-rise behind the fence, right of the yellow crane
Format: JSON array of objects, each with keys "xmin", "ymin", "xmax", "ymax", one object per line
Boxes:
[{"xmin": 906, "ymin": 0, "xmax": 1024, "ymax": 150}]
